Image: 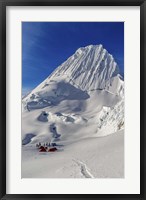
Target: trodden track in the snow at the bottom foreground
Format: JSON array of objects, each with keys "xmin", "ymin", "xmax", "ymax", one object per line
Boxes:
[{"xmin": 73, "ymin": 159, "xmax": 94, "ymax": 178}]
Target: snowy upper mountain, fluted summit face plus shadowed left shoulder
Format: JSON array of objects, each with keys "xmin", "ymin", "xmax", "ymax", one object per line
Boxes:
[{"xmin": 23, "ymin": 44, "xmax": 124, "ymax": 111}]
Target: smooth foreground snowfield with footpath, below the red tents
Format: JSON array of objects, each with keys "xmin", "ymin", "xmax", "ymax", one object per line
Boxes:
[{"xmin": 22, "ymin": 131, "xmax": 124, "ymax": 178}]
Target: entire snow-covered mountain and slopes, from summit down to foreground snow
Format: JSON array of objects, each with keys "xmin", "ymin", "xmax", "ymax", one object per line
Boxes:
[{"xmin": 22, "ymin": 45, "xmax": 124, "ymax": 178}]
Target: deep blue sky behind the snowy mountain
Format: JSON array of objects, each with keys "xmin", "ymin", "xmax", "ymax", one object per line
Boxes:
[{"xmin": 22, "ymin": 22, "xmax": 124, "ymax": 94}]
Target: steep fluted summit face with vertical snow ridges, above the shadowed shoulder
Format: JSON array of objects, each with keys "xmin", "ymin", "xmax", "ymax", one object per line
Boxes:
[{"xmin": 50, "ymin": 45, "xmax": 119, "ymax": 90}]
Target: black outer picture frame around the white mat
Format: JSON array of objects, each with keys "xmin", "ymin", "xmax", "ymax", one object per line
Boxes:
[{"xmin": 0, "ymin": 0, "xmax": 146, "ymax": 200}]
